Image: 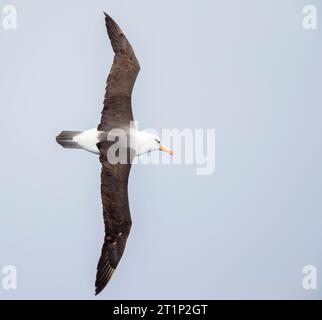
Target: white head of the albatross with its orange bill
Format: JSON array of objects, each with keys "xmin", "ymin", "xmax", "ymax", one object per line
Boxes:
[{"xmin": 136, "ymin": 131, "xmax": 173, "ymax": 155}]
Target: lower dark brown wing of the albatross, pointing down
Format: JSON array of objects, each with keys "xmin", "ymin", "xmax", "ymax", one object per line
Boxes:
[{"xmin": 95, "ymin": 145, "xmax": 132, "ymax": 294}]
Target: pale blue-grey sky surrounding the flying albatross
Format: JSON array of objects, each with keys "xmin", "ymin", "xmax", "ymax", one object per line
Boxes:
[{"xmin": 0, "ymin": 0, "xmax": 322, "ymax": 299}]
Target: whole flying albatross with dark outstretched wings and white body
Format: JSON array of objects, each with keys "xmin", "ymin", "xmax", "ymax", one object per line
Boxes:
[{"xmin": 56, "ymin": 12, "xmax": 173, "ymax": 295}]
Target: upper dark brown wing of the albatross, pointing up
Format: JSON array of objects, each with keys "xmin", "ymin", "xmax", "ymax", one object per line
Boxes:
[{"xmin": 98, "ymin": 12, "xmax": 140, "ymax": 131}]
